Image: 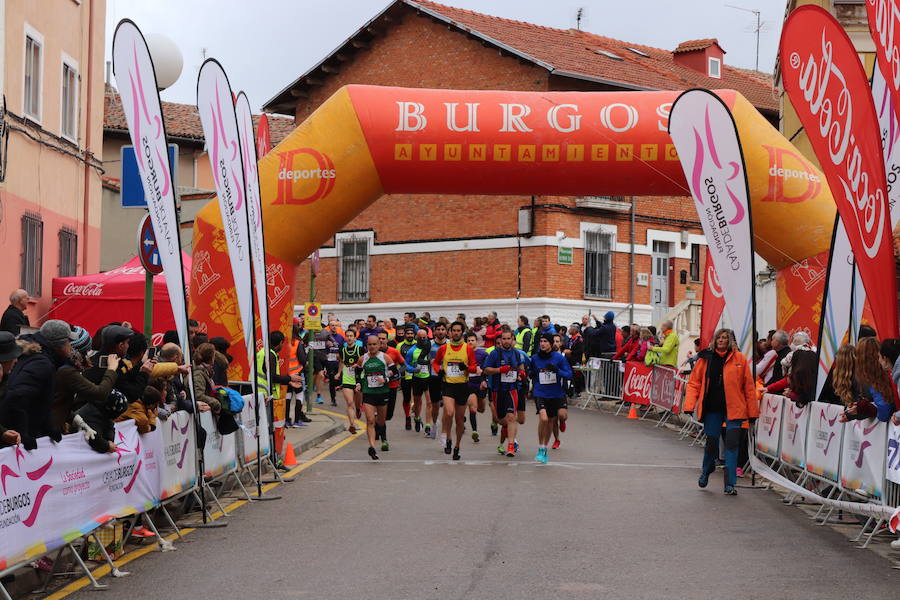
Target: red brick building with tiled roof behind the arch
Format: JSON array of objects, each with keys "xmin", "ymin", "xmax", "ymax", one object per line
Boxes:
[{"xmin": 264, "ymin": 0, "xmax": 778, "ymax": 329}]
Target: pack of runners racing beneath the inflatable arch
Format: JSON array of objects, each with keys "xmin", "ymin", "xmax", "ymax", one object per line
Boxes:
[{"xmin": 316, "ymin": 317, "xmax": 573, "ymax": 463}]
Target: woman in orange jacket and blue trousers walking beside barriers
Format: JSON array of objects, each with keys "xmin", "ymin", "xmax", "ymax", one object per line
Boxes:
[{"xmin": 684, "ymin": 329, "xmax": 759, "ymax": 496}]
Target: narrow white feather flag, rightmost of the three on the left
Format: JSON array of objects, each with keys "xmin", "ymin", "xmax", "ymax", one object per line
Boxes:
[{"xmin": 234, "ymin": 92, "xmax": 269, "ymax": 390}]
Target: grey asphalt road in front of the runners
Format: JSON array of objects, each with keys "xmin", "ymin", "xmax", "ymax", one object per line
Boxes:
[{"xmin": 67, "ymin": 410, "xmax": 898, "ymax": 600}]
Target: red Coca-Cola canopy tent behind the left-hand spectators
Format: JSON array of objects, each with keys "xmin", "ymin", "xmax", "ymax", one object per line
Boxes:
[{"xmin": 47, "ymin": 252, "xmax": 191, "ymax": 344}]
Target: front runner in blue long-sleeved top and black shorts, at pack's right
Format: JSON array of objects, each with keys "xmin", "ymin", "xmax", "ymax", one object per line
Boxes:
[{"xmin": 531, "ymin": 334, "xmax": 572, "ymax": 464}]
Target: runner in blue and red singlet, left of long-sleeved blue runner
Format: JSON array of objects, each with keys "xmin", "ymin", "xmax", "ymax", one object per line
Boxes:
[{"xmin": 483, "ymin": 325, "xmax": 525, "ymax": 457}]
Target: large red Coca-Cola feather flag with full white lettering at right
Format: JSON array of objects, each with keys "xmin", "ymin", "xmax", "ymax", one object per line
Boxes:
[{"xmin": 779, "ymin": 5, "xmax": 897, "ymax": 339}]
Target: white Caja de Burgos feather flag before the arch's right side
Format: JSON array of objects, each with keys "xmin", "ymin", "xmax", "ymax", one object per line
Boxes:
[{"xmin": 669, "ymin": 89, "xmax": 755, "ymax": 356}]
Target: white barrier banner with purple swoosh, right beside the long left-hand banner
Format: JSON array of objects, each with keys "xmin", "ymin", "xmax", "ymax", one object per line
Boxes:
[{"xmin": 160, "ymin": 410, "xmax": 197, "ymax": 500}]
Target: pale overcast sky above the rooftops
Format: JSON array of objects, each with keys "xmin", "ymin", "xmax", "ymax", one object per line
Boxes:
[{"xmin": 106, "ymin": 0, "xmax": 786, "ymax": 110}]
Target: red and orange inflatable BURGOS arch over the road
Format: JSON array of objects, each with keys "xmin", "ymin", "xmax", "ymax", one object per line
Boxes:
[{"xmin": 190, "ymin": 86, "xmax": 835, "ymax": 376}]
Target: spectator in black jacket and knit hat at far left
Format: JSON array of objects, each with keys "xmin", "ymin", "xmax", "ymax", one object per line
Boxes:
[{"xmin": 0, "ymin": 319, "xmax": 76, "ymax": 450}]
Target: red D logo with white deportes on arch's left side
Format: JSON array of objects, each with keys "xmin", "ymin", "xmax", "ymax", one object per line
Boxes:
[{"xmin": 275, "ymin": 148, "xmax": 337, "ymax": 204}]
